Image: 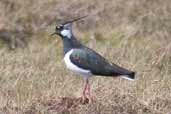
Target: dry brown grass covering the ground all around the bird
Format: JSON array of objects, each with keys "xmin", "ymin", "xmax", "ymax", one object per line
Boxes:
[{"xmin": 0, "ymin": 0, "xmax": 171, "ymax": 114}]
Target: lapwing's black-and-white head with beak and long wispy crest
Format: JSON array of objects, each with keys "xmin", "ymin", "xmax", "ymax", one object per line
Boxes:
[{"xmin": 52, "ymin": 16, "xmax": 87, "ymax": 39}]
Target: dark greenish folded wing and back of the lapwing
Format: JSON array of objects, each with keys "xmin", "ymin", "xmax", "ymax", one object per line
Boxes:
[{"xmin": 70, "ymin": 47, "xmax": 134, "ymax": 76}]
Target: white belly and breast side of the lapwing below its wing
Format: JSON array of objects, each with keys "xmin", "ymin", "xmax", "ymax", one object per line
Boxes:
[{"xmin": 64, "ymin": 49, "xmax": 91, "ymax": 76}]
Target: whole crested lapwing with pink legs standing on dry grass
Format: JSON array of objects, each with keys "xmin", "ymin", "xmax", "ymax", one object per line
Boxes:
[{"xmin": 52, "ymin": 17, "xmax": 135, "ymax": 100}]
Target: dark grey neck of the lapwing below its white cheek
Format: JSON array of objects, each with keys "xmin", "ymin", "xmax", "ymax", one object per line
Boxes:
[{"xmin": 62, "ymin": 35, "xmax": 82, "ymax": 55}]
